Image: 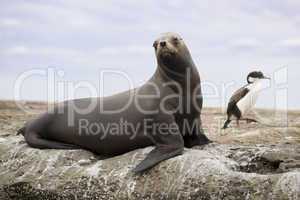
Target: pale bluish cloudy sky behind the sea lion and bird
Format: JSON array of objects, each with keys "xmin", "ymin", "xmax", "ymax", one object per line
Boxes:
[{"xmin": 0, "ymin": 0, "xmax": 300, "ymax": 109}]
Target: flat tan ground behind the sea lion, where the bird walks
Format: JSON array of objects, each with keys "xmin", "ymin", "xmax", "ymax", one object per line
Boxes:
[{"xmin": 0, "ymin": 101, "xmax": 300, "ymax": 144}]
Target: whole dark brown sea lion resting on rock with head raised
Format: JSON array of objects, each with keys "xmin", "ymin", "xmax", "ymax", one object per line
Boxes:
[{"xmin": 19, "ymin": 33, "xmax": 210, "ymax": 172}]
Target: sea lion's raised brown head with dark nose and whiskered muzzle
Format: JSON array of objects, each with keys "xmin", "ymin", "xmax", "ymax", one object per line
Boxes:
[{"xmin": 153, "ymin": 32, "xmax": 192, "ymax": 70}]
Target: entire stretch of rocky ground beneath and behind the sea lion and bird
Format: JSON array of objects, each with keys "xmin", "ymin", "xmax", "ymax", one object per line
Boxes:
[{"xmin": 0, "ymin": 101, "xmax": 300, "ymax": 200}]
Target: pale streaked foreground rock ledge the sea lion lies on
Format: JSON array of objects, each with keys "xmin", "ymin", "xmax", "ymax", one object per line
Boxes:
[{"xmin": 0, "ymin": 136, "xmax": 300, "ymax": 200}]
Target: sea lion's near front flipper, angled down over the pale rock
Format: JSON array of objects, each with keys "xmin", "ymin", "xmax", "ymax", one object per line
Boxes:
[{"xmin": 133, "ymin": 116, "xmax": 184, "ymax": 173}]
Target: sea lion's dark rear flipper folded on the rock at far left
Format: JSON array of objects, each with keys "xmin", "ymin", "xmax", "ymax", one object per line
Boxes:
[{"xmin": 25, "ymin": 132, "xmax": 79, "ymax": 149}]
